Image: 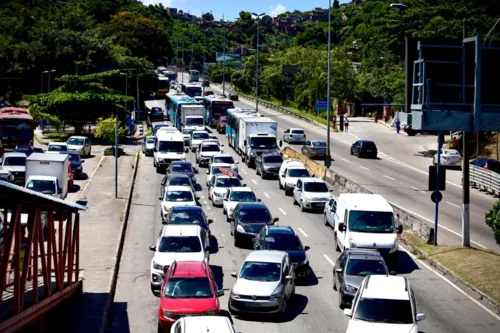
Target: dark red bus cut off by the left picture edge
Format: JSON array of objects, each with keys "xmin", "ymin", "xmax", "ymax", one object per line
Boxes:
[{"xmin": 0, "ymin": 107, "xmax": 35, "ymax": 151}]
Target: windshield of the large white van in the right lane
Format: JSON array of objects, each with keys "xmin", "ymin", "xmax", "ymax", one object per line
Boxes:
[{"xmin": 349, "ymin": 210, "xmax": 394, "ymax": 234}]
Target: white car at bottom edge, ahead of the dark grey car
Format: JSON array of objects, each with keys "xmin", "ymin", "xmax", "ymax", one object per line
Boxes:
[{"xmin": 344, "ymin": 275, "xmax": 425, "ymax": 333}]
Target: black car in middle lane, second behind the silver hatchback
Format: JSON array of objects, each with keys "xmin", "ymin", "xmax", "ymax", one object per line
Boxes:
[{"xmin": 229, "ymin": 202, "xmax": 279, "ymax": 246}]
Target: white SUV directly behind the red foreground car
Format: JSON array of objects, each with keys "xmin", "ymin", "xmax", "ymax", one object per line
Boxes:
[{"xmin": 149, "ymin": 224, "xmax": 210, "ymax": 294}]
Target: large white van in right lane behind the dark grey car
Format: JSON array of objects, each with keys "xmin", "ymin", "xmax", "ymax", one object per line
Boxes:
[{"xmin": 324, "ymin": 193, "xmax": 403, "ymax": 264}]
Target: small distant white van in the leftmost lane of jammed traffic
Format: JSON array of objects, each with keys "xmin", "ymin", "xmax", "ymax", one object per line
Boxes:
[{"xmin": 153, "ymin": 127, "xmax": 186, "ymax": 173}]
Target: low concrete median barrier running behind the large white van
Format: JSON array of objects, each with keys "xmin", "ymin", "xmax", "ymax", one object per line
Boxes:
[{"xmin": 282, "ymin": 147, "xmax": 434, "ymax": 244}]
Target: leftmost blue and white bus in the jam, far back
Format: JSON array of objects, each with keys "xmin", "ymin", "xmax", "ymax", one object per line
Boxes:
[{"xmin": 165, "ymin": 93, "xmax": 204, "ymax": 131}]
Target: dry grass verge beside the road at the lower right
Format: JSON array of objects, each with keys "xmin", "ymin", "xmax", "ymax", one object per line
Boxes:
[{"xmin": 403, "ymin": 233, "xmax": 500, "ymax": 302}]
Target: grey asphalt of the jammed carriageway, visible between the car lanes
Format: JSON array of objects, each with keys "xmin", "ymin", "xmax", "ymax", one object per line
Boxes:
[{"xmin": 109, "ymin": 117, "xmax": 500, "ymax": 333}]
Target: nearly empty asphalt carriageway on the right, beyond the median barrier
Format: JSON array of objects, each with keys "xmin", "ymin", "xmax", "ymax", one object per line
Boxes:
[{"xmin": 196, "ymin": 76, "xmax": 500, "ymax": 252}]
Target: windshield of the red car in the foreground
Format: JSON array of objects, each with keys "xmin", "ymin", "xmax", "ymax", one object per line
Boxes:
[{"xmin": 164, "ymin": 277, "xmax": 214, "ymax": 298}]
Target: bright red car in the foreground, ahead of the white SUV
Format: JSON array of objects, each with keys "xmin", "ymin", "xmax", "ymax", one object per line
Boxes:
[{"xmin": 158, "ymin": 261, "xmax": 224, "ymax": 332}]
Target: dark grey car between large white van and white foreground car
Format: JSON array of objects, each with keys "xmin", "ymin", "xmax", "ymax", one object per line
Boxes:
[{"xmin": 333, "ymin": 249, "xmax": 394, "ymax": 309}]
